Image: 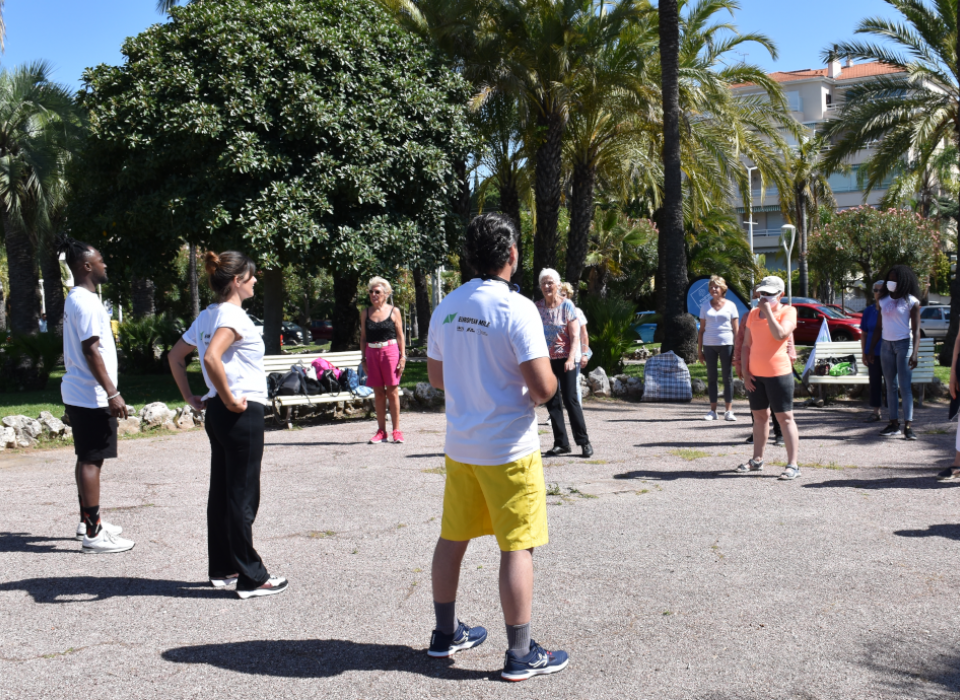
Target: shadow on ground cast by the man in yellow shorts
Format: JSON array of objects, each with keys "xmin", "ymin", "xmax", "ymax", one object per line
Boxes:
[{"xmin": 162, "ymin": 639, "xmax": 499, "ymax": 680}]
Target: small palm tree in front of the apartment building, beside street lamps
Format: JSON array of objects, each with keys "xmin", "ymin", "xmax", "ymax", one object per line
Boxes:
[{"xmin": 780, "ymin": 135, "xmax": 836, "ymax": 297}]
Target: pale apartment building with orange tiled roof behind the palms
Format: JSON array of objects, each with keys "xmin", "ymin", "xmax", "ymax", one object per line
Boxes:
[{"xmin": 733, "ymin": 61, "xmax": 900, "ymax": 269}]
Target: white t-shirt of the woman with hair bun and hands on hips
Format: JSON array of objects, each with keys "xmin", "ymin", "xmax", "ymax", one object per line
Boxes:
[{"xmin": 183, "ymin": 304, "xmax": 267, "ymax": 404}]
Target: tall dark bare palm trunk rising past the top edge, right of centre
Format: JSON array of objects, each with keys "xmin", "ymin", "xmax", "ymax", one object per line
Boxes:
[{"xmin": 659, "ymin": 0, "xmax": 697, "ymax": 362}]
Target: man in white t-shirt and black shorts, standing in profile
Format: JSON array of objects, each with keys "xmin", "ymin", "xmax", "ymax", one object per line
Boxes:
[{"xmin": 60, "ymin": 237, "xmax": 134, "ymax": 554}]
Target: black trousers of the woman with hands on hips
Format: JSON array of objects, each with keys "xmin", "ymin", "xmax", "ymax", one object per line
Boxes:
[{"xmin": 205, "ymin": 396, "xmax": 270, "ymax": 591}]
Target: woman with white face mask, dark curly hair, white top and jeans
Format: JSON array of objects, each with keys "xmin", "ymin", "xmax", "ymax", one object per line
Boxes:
[{"xmin": 877, "ymin": 265, "xmax": 920, "ymax": 440}]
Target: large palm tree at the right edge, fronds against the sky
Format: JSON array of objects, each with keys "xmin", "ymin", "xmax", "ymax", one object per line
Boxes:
[{"xmin": 824, "ymin": 0, "xmax": 960, "ymax": 365}]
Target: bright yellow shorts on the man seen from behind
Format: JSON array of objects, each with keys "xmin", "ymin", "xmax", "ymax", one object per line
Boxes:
[{"xmin": 440, "ymin": 450, "xmax": 548, "ymax": 552}]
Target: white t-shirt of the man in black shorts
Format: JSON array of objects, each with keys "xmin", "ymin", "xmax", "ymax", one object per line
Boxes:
[{"xmin": 60, "ymin": 287, "xmax": 117, "ymax": 408}]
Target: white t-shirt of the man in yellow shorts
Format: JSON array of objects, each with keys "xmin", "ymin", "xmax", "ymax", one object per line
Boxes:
[{"xmin": 427, "ymin": 279, "xmax": 549, "ymax": 466}]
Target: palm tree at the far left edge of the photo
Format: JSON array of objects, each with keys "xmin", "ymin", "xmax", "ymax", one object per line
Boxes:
[{"xmin": 0, "ymin": 62, "xmax": 74, "ymax": 333}]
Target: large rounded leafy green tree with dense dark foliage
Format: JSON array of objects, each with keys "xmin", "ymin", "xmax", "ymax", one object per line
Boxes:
[{"xmin": 72, "ymin": 0, "xmax": 471, "ymax": 353}]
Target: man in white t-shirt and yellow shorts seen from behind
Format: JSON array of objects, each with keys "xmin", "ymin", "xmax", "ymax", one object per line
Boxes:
[{"xmin": 427, "ymin": 214, "xmax": 568, "ymax": 681}]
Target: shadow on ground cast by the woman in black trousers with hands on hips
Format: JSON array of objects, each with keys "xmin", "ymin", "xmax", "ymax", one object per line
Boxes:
[{"xmin": 0, "ymin": 576, "xmax": 236, "ymax": 603}]
